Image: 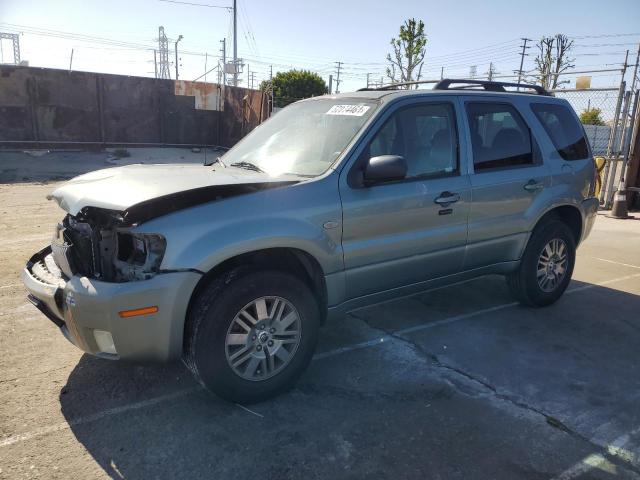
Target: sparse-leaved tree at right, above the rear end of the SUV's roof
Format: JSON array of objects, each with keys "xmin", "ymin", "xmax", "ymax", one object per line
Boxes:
[{"xmin": 535, "ymin": 33, "xmax": 575, "ymax": 90}]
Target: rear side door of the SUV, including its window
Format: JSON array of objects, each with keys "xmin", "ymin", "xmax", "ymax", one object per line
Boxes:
[{"xmin": 464, "ymin": 97, "xmax": 551, "ymax": 270}]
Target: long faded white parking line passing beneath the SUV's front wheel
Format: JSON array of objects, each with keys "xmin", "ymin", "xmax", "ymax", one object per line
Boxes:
[{"xmin": 0, "ymin": 273, "xmax": 640, "ymax": 450}]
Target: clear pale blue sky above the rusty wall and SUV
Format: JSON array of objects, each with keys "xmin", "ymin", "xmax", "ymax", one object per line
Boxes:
[{"xmin": 0, "ymin": 0, "xmax": 640, "ymax": 91}]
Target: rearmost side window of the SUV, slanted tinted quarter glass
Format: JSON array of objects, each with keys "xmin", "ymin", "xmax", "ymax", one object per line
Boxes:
[{"xmin": 531, "ymin": 103, "xmax": 589, "ymax": 160}]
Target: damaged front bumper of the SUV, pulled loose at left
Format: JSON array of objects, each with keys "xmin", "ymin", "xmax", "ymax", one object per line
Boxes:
[{"xmin": 22, "ymin": 247, "xmax": 201, "ymax": 361}]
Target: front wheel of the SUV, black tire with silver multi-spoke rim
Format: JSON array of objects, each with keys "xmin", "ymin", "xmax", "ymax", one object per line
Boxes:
[{"xmin": 185, "ymin": 268, "xmax": 320, "ymax": 404}]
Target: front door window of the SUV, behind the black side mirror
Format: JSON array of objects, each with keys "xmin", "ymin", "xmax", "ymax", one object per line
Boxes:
[{"xmin": 364, "ymin": 103, "xmax": 458, "ymax": 178}]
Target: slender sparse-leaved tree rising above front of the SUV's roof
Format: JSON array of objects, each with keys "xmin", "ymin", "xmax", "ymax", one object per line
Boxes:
[{"xmin": 387, "ymin": 18, "xmax": 427, "ymax": 88}]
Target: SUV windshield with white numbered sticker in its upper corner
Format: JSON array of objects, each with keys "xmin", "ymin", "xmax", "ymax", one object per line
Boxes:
[{"xmin": 222, "ymin": 98, "xmax": 377, "ymax": 176}]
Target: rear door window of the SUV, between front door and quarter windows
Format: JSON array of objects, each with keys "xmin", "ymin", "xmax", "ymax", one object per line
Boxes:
[{"xmin": 466, "ymin": 102, "xmax": 534, "ymax": 172}]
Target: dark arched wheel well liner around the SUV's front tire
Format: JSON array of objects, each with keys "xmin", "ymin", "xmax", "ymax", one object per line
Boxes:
[{"xmin": 183, "ymin": 248, "xmax": 327, "ymax": 354}]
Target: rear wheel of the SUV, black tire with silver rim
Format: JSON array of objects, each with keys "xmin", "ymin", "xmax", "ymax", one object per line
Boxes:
[{"xmin": 507, "ymin": 219, "xmax": 576, "ymax": 307}]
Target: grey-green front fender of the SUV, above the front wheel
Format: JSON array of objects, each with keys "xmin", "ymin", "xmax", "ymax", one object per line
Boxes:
[{"xmin": 136, "ymin": 176, "xmax": 343, "ymax": 275}]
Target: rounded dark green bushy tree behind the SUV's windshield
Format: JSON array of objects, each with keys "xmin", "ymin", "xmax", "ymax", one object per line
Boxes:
[{"xmin": 260, "ymin": 70, "xmax": 327, "ymax": 107}]
